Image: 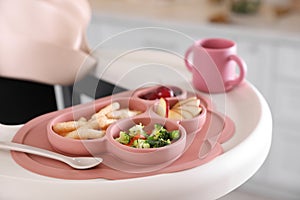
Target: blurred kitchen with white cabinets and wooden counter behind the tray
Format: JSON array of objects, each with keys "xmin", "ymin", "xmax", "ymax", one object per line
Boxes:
[{"xmin": 57, "ymin": 0, "xmax": 300, "ymax": 200}]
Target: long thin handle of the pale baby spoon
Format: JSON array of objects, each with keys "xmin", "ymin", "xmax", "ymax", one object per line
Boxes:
[{"xmin": 0, "ymin": 141, "xmax": 66, "ymax": 162}]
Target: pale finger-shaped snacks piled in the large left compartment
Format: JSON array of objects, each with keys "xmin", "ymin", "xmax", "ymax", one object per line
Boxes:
[{"xmin": 52, "ymin": 102, "xmax": 141, "ymax": 139}]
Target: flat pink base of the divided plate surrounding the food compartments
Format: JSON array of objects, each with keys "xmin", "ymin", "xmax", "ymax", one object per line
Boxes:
[{"xmin": 12, "ymin": 85, "xmax": 235, "ymax": 180}]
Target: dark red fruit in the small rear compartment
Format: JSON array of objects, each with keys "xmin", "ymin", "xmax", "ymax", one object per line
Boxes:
[{"xmin": 142, "ymin": 86, "xmax": 180, "ymax": 100}]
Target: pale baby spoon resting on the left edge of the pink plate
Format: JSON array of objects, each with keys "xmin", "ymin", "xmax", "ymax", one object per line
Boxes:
[{"xmin": 0, "ymin": 141, "xmax": 103, "ymax": 169}]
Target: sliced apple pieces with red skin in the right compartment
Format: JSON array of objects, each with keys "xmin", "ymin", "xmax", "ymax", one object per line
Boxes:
[{"xmin": 156, "ymin": 97, "xmax": 202, "ymax": 120}]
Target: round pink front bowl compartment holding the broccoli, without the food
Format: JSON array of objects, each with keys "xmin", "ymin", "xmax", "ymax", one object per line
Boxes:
[{"xmin": 107, "ymin": 116, "xmax": 186, "ymax": 165}]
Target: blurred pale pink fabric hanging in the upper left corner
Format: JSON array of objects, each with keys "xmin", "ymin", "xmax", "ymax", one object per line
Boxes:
[{"xmin": 0, "ymin": 0, "xmax": 96, "ymax": 85}]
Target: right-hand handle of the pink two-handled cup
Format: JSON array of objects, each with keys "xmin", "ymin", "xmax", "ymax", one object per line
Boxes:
[{"xmin": 225, "ymin": 55, "xmax": 247, "ymax": 87}]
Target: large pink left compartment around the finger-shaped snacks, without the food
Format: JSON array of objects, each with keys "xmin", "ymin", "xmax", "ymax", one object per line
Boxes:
[{"xmin": 47, "ymin": 98, "xmax": 148, "ymax": 156}]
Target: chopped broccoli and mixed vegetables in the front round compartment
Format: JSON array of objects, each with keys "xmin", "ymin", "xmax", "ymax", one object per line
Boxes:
[{"xmin": 115, "ymin": 124, "xmax": 180, "ymax": 149}]
